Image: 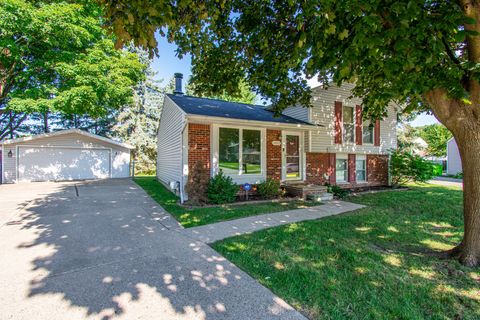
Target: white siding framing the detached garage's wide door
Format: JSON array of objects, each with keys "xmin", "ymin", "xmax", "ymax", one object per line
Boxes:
[{"xmin": 3, "ymin": 132, "xmax": 130, "ymax": 183}]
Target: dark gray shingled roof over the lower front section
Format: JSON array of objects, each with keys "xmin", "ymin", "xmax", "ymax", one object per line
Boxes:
[{"xmin": 167, "ymin": 94, "xmax": 312, "ymax": 125}]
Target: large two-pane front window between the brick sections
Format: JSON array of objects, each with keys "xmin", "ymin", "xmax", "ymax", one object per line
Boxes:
[{"xmin": 218, "ymin": 128, "xmax": 262, "ymax": 175}]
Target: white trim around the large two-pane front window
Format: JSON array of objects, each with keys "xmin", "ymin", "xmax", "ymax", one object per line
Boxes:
[{"xmin": 210, "ymin": 124, "xmax": 267, "ymax": 183}]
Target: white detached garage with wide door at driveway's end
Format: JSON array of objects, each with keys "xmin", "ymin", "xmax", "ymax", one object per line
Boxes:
[{"xmin": 0, "ymin": 129, "xmax": 133, "ymax": 183}]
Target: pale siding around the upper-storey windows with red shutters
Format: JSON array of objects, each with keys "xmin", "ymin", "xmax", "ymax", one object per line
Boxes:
[{"xmin": 309, "ymin": 84, "xmax": 397, "ymax": 154}]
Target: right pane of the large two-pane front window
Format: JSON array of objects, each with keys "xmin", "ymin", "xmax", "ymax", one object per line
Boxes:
[{"xmin": 242, "ymin": 130, "xmax": 262, "ymax": 174}]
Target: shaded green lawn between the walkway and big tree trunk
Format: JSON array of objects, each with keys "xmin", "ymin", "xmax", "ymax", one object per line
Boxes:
[{"xmin": 213, "ymin": 185, "xmax": 480, "ymax": 319}]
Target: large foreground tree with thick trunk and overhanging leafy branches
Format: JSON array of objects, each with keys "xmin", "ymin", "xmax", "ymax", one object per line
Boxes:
[{"xmin": 101, "ymin": 0, "xmax": 480, "ymax": 266}]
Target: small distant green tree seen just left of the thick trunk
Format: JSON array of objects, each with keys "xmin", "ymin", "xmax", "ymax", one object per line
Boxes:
[{"xmin": 416, "ymin": 124, "xmax": 452, "ymax": 157}]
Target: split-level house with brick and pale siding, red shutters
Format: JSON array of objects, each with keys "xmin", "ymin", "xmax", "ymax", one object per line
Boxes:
[{"xmin": 157, "ymin": 74, "xmax": 397, "ymax": 200}]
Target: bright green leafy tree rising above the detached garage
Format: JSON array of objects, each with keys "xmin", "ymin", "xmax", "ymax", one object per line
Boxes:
[{"xmin": 0, "ymin": 0, "xmax": 144, "ymax": 139}]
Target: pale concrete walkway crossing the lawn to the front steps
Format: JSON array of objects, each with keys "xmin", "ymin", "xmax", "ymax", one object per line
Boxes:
[{"xmin": 181, "ymin": 201, "xmax": 365, "ymax": 243}]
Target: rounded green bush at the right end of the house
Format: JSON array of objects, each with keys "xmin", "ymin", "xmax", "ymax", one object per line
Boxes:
[{"xmin": 390, "ymin": 151, "xmax": 434, "ymax": 185}]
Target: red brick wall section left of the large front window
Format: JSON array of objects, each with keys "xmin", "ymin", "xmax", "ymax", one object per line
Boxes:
[{"xmin": 188, "ymin": 123, "xmax": 210, "ymax": 174}]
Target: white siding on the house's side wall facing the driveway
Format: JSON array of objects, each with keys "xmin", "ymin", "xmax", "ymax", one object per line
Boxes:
[{"xmin": 157, "ymin": 96, "xmax": 185, "ymax": 189}]
